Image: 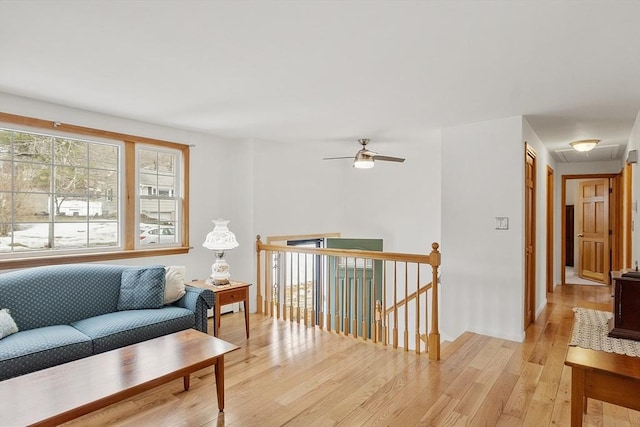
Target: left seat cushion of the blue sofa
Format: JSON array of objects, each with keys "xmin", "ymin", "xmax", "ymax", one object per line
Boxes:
[{"xmin": 0, "ymin": 325, "xmax": 93, "ymax": 381}]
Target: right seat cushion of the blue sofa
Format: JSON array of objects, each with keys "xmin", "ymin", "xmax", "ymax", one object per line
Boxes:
[{"xmin": 71, "ymin": 306, "xmax": 195, "ymax": 353}]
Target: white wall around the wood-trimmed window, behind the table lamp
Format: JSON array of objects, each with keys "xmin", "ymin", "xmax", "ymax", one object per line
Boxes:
[{"xmin": 0, "ymin": 93, "xmax": 255, "ymax": 288}]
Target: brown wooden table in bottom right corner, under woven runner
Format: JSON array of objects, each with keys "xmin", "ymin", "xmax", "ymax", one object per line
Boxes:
[{"xmin": 564, "ymin": 347, "xmax": 640, "ymax": 427}]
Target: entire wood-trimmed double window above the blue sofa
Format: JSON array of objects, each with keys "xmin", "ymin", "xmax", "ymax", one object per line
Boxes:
[{"xmin": 0, "ymin": 113, "xmax": 188, "ymax": 268}]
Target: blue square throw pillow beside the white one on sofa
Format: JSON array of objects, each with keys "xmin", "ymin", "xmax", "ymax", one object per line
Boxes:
[{"xmin": 118, "ymin": 266, "xmax": 165, "ymax": 310}]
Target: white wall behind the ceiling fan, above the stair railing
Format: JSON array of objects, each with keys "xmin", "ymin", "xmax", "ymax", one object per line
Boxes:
[{"xmin": 253, "ymin": 132, "xmax": 440, "ymax": 253}]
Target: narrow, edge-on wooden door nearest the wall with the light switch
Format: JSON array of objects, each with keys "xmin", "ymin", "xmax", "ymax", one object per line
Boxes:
[{"xmin": 524, "ymin": 146, "xmax": 536, "ymax": 329}]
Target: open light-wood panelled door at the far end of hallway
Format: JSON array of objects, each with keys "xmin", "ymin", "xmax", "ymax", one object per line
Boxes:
[{"xmin": 576, "ymin": 178, "xmax": 610, "ymax": 284}]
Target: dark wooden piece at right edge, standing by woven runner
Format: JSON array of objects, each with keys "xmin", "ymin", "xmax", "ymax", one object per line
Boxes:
[{"xmin": 609, "ymin": 273, "xmax": 640, "ymax": 341}]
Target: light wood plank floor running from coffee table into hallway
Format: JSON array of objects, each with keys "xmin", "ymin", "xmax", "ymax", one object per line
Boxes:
[{"xmin": 61, "ymin": 285, "xmax": 640, "ymax": 427}]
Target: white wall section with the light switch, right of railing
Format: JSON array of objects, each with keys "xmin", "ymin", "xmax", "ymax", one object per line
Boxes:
[{"xmin": 440, "ymin": 116, "xmax": 525, "ymax": 341}]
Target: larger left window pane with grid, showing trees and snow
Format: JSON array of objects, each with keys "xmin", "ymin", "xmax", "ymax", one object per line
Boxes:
[{"xmin": 0, "ymin": 129, "xmax": 122, "ymax": 253}]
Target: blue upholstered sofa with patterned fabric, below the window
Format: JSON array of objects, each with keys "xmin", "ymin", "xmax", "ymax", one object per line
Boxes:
[{"xmin": 0, "ymin": 264, "xmax": 214, "ymax": 381}]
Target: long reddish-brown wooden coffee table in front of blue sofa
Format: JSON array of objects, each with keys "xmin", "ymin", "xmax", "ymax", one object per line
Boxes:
[{"xmin": 0, "ymin": 329, "xmax": 239, "ymax": 426}]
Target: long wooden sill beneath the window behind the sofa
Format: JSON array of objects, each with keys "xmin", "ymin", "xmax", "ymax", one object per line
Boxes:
[{"xmin": 0, "ymin": 247, "xmax": 191, "ymax": 270}]
